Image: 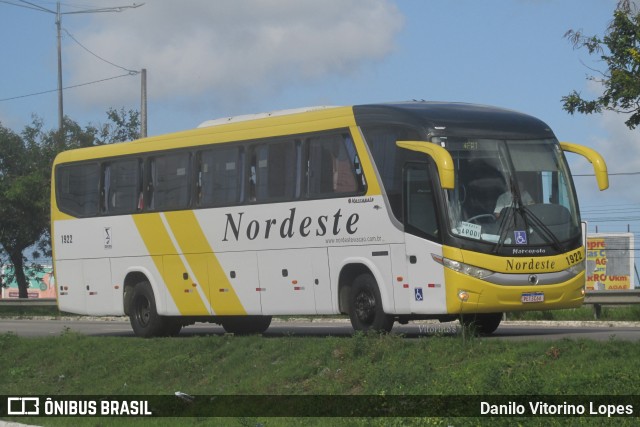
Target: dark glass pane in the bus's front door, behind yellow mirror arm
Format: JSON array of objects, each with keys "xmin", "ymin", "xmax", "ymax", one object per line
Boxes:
[{"xmin": 404, "ymin": 163, "xmax": 440, "ymax": 241}]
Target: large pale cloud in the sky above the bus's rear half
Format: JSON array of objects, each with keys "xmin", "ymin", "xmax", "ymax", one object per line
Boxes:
[{"xmin": 63, "ymin": 0, "xmax": 403, "ymax": 110}]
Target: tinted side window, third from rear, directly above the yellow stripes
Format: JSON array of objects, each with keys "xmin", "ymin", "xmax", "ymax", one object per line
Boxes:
[{"xmin": 149, "ymin": 152, "xmax": 190, "ymax": 210}]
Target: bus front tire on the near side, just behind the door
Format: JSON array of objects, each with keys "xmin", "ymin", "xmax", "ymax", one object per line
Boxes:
[{"xmin": 349, "ymin": 273, "xmax": 394, "ymax": 332}]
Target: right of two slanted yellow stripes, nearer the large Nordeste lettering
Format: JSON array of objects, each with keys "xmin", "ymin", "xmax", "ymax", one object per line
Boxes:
[{"xmin": 164, "ymin": 211, "xmax": 247, "ymax": 316}]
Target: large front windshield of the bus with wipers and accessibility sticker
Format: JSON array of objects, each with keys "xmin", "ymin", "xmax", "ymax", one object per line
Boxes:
[{"xmin": 441, "ymin": 138, "xmax": 580, "ymax": 251}]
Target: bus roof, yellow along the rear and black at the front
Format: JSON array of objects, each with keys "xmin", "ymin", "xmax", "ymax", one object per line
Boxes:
[{"xmin": 56, "ymin": 101, "xmax": 554, "ymax": 163}]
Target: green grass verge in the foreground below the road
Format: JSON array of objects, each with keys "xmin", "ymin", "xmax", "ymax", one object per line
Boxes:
[{"xmin": 0, "ymin": 332, "xmax": 640, "ymax": 426}]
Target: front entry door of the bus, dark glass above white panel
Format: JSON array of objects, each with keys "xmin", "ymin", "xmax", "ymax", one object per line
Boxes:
[{"xmin": 403, "ymin": 163, "xmax": 447, "ymax": 314}]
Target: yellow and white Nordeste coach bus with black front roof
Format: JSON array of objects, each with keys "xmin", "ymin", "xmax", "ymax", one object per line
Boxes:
[{"xmin": 51, "ymin": 101, "xmax": 608, "ymax": 337}]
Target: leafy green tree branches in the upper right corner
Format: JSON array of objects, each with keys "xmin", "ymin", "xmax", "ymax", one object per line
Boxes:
[{"xmin": 562, "ymin": 0, "xmax": 640, "ymax": 129}]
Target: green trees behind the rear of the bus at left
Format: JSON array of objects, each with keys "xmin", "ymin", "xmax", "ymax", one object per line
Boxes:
[{"xmin": 0, "ymin": 108, "xmax": 140, "ymax": 298}]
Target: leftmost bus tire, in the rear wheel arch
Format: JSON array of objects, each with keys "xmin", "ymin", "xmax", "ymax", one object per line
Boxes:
[{"xmin": 129, "ymin": 281, "xmax": 166, "ymax": 338}]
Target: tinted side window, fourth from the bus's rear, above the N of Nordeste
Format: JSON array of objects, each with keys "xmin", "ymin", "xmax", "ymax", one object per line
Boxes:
[{"xmin": 197, "ymin": 147, "xmax": 244, "ymax": 206}]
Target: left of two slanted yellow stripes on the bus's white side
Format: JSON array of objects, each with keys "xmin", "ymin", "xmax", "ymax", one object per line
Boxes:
[{"xmin": 132, "ymin": 213, "xmax": 209, "ymax": 315}]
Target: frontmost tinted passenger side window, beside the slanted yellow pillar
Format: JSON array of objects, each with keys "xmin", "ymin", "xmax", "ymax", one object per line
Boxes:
[{"xmin": 307, "ymin": 134, "xmax": 365, "ymax": 198}]
